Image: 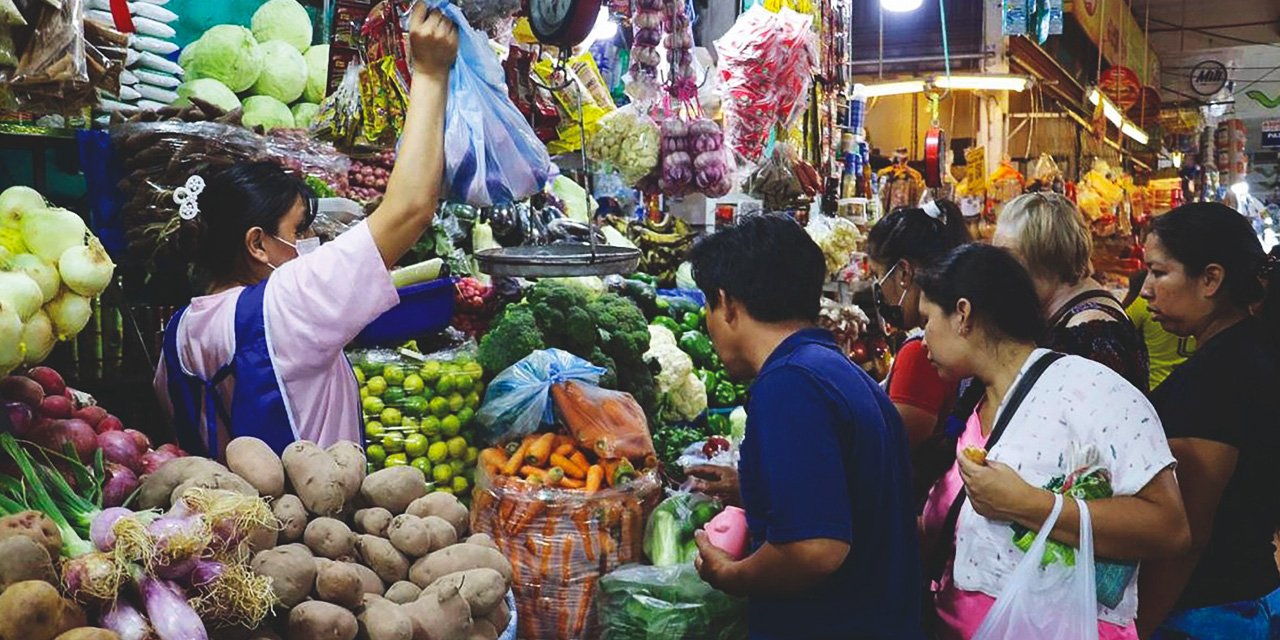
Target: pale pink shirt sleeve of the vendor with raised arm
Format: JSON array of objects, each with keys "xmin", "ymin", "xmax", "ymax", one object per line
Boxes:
[{"xmin": 264, "ymin": 223, "xmax": 399, "ymax": 380}]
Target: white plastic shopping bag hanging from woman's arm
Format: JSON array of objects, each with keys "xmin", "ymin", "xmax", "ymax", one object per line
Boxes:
[{"xmin": 973, "ymin": 494, "xmax": 1098, "ymax": 640}]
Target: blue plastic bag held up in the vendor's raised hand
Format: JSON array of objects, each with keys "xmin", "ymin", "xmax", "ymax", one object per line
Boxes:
[{"xmin": 406, "ymin": 0, "xmax": 552, "ymax": 206}]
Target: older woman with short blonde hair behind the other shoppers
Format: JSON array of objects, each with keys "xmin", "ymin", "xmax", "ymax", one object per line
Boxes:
[{"xmin": 995, "ymin": 193, "xmax": 1149, "ymax": 392}]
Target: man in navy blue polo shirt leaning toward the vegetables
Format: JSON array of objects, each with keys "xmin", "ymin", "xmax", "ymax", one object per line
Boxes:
[{"xmin": 690, "ymin": 215, "xmax": 923, "ymax": 640}]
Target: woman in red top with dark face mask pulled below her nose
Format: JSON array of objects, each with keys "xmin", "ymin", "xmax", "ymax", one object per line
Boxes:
[{"xmin": 868, "ymin": 200, "xmax": 969, "ymax": 500}]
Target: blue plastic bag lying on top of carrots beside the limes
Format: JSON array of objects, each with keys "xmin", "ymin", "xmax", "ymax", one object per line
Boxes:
[{"xmin": 476, "ymin": 349, "xmax": 605, "ymax": 442}]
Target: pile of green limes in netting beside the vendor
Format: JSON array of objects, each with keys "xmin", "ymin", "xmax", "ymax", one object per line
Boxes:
[{"xmin": 353, "ymin": 357, "xmax": 484, "ymax": 497}]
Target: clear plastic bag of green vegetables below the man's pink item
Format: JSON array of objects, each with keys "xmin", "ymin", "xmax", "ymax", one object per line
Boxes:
[{"xmin": 599, "ymin": 564, "xmax": 746, "ymax": 640}]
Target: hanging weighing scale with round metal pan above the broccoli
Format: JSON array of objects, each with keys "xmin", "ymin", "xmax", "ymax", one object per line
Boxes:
[{"xmin": 475, "ymin": 0, "xmax": 640, "ymax": 278}]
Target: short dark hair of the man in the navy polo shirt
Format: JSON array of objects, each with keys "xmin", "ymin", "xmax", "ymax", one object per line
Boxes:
[{"xmin": 689, "ymin": 214, "xmax": 827, "ymax": 323}]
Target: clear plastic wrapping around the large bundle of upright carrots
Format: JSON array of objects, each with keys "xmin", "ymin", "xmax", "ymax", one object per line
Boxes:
[{"xmin": 471, "ymin": 471, "xmax": 665, "ymax": 640}]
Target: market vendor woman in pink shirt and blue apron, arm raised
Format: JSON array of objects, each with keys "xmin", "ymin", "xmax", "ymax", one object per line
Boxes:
[{"xmin": 155, "ymin": 4, "xmax": 458, "ymax": 457}]
